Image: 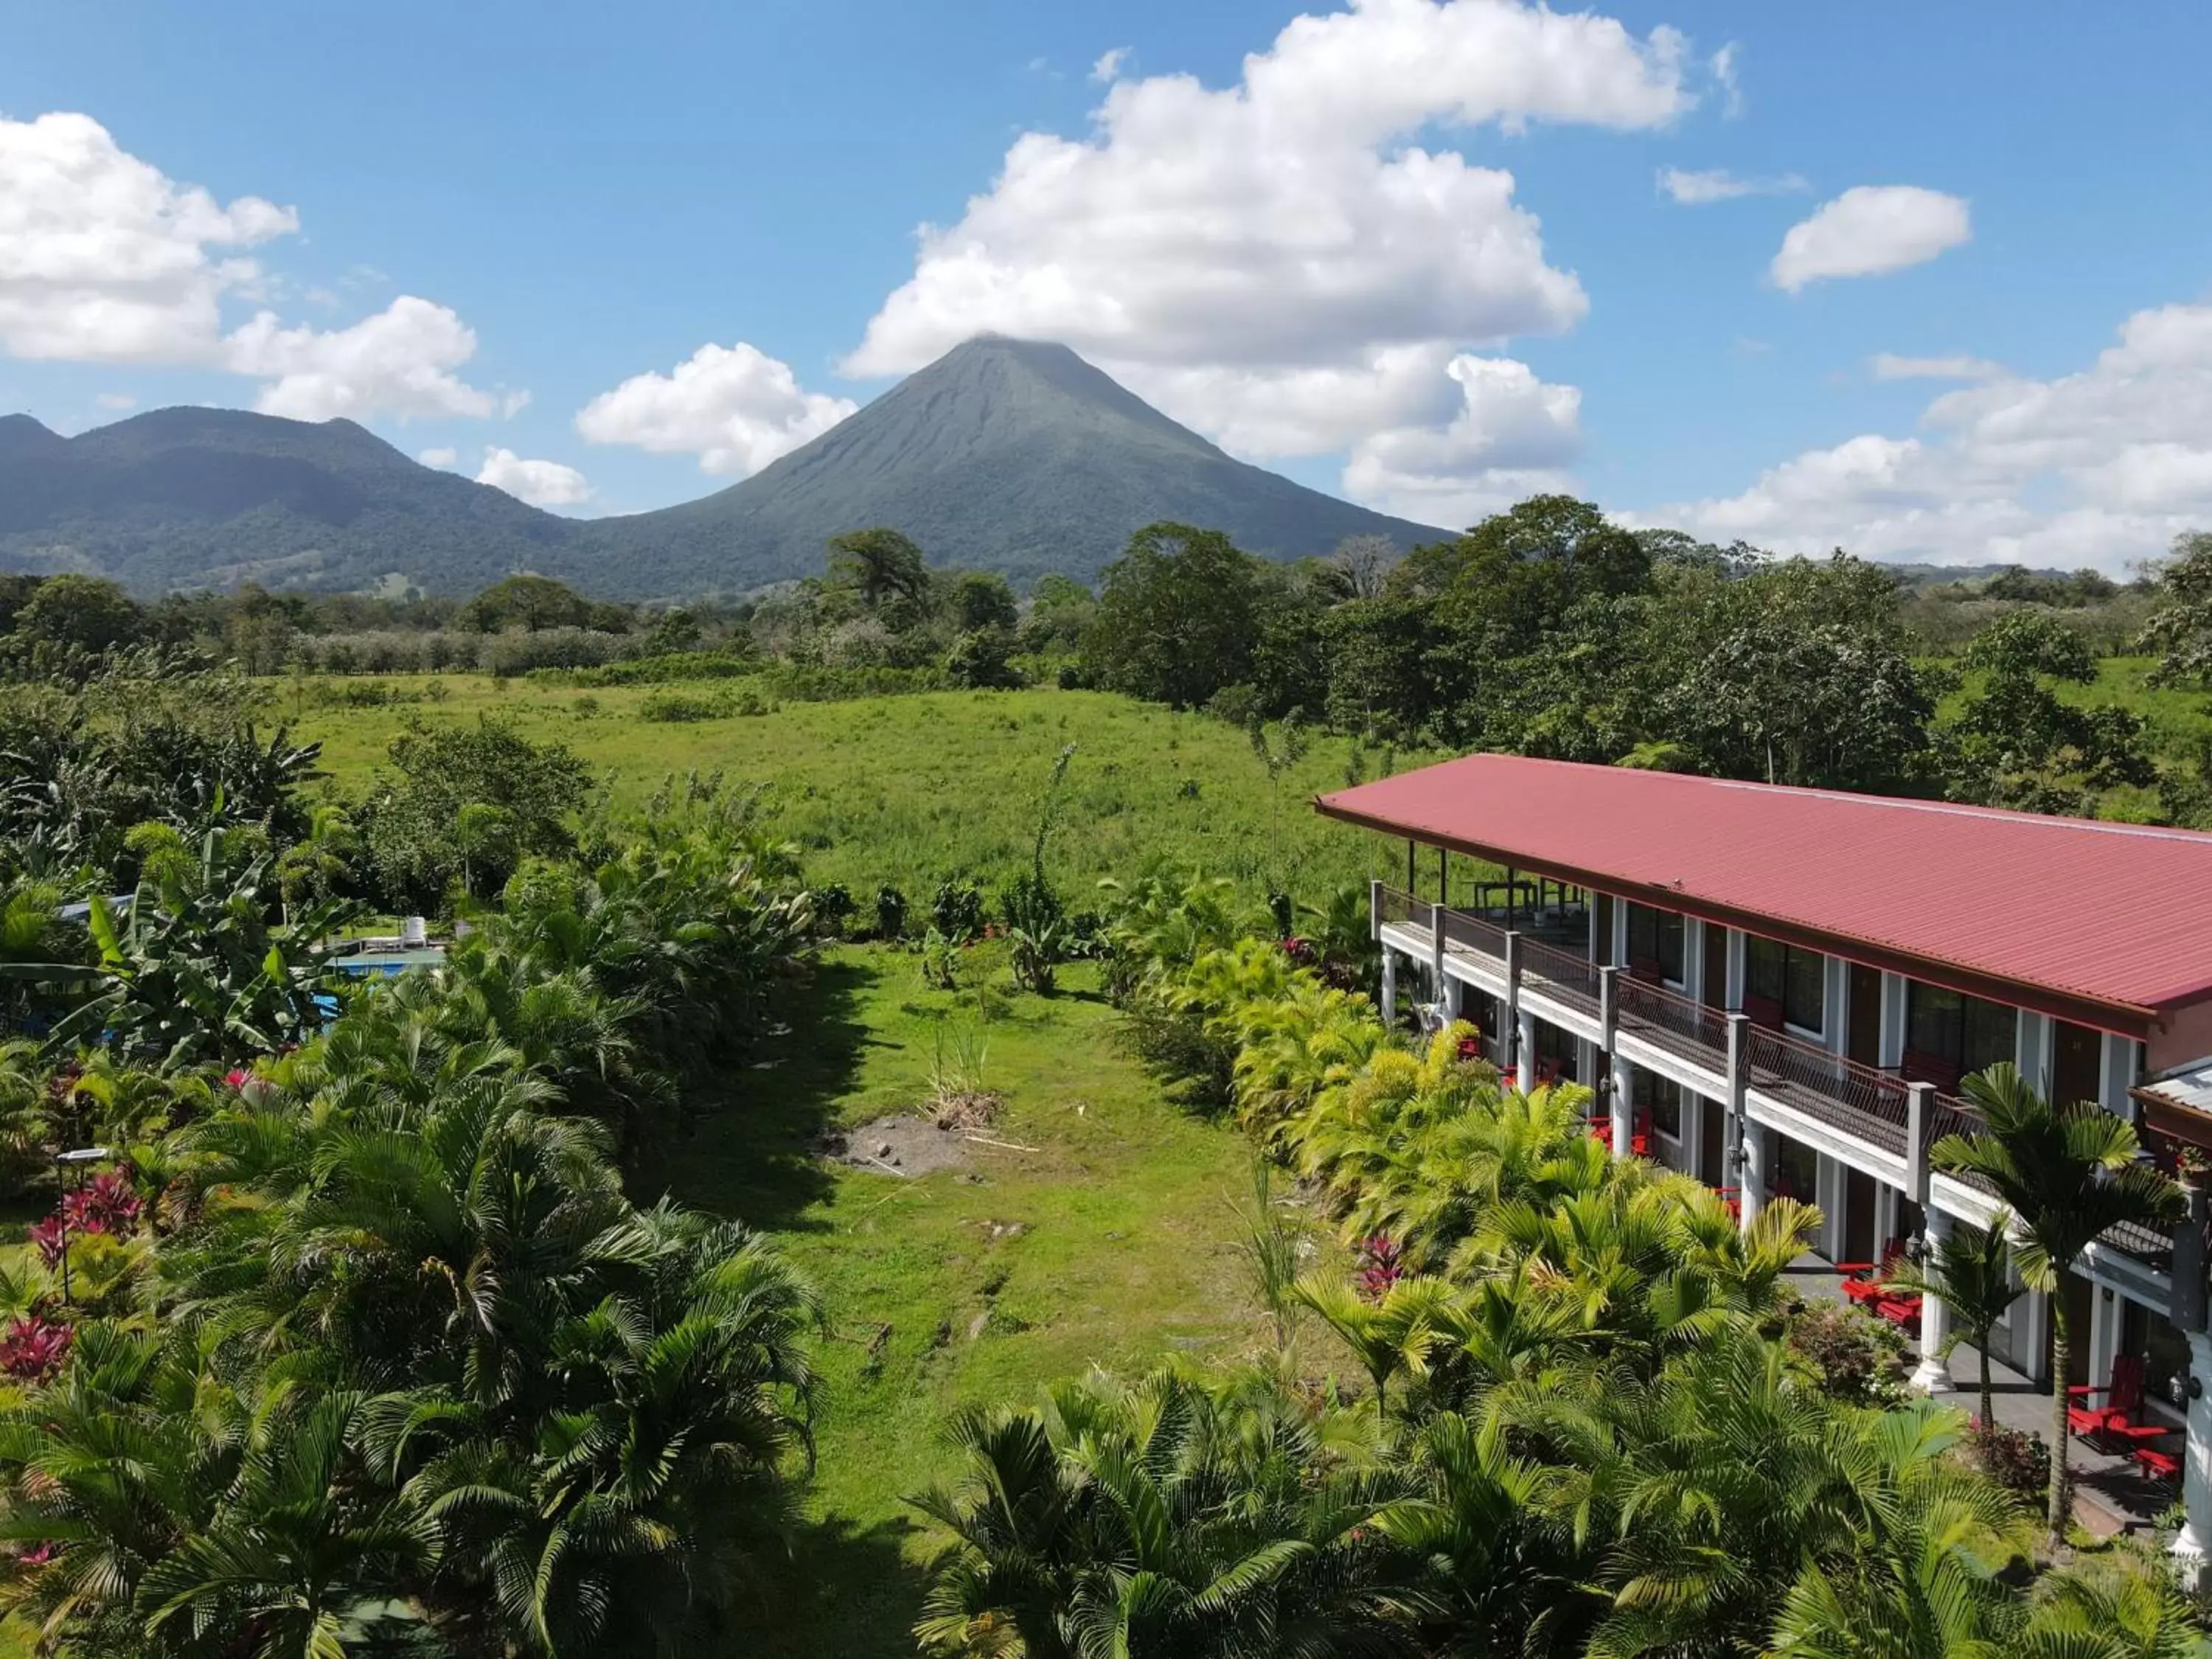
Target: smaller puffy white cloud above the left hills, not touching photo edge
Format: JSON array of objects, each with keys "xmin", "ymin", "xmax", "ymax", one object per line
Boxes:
[{"xmin": 223, "ymin": 294, "xmax": 493, "ymax": 420}]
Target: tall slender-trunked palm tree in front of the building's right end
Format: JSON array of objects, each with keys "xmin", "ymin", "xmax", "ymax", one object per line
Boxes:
[{"xmin": 1929, "ymin": 1062, "xmax": 2183, "ymax": 1548}]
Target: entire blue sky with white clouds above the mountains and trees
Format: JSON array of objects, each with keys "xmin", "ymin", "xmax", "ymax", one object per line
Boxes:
[{"xmin": 0, "ymin": 0, "xmax": 2212, "ymax": 573}]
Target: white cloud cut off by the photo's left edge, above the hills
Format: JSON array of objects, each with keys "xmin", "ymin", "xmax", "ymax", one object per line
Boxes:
[{"xmin": 0, "ymin": 115, "xmax": 299, "ymax": 363}]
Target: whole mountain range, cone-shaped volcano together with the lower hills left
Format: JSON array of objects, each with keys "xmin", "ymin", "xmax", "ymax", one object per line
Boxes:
[{"xmin": 0, "ymin": 338, "xmax": 1442, "ymax": 597}]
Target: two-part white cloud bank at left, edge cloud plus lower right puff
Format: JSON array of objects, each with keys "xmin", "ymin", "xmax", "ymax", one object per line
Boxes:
[{"xmin": 0, "ymin": 113, "xmax": 504, "ymax": 420}]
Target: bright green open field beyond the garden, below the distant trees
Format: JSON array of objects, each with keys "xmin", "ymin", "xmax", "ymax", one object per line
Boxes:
[{"xmin": 281, "ymin": 675, "xmax": 1427, "ymax": 907}]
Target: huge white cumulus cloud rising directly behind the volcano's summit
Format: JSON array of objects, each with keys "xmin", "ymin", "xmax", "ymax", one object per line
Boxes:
[{"xmin": 843, "ymin": 0, "xmax": 1672, "ymax": 518}]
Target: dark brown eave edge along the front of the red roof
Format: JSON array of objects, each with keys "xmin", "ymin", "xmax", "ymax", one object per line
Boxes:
[{"xmin": 1314, "ymin": 796, "xmax": 2150, "ymax": 1042}]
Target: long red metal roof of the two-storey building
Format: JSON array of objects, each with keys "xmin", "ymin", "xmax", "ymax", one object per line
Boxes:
[{"xmin": 1314, "ymin": 754, "xmax": 2212, "ymax": 1029}]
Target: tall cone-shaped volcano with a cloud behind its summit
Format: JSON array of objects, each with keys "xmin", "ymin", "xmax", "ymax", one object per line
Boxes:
[{"xmin": 602, "ymin": 336, "xmax": 1444, "ymax": 588}]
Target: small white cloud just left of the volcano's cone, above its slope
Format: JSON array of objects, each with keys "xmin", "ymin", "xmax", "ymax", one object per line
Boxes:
[{"xmin": 575, "ymin": 341, "xmax": 858, "ymax": 478}]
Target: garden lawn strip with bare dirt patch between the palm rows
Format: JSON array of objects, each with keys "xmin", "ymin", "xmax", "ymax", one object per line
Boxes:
[{"xmin": 635, "ymin": 945, "xmax": 1265, "ymax": 1659}]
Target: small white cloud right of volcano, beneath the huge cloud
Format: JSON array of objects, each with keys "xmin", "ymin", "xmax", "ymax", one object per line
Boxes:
[{"xmin": 1345, "ymin": 354, "xmax": 1582, "ymax": 524}]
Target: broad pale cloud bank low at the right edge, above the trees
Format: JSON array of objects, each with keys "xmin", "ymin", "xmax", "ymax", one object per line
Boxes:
[{"xmin": 1650, "ymin": 305, "xmax": 2212, "ymax": 573}]
